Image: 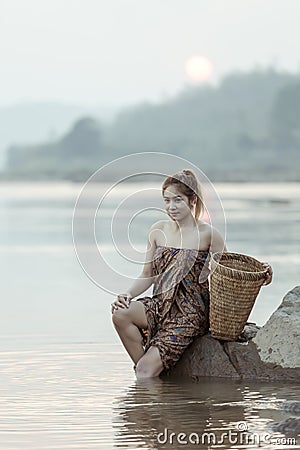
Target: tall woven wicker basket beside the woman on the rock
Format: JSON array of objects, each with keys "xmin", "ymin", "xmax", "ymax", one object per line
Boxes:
[{"xmin": 209, "ymin": 252, "xmax": 266, "ymax": 341}]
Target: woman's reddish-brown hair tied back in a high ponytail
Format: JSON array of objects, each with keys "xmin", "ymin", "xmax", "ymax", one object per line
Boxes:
[{"xmin": 162, "ymin": 169, "xmax": 204, "ymax": 220}]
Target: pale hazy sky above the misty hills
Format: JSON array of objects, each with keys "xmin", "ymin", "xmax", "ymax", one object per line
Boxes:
[{"xmin": 0, "ymin": 0, "xmax": 300, "ymax": 106}]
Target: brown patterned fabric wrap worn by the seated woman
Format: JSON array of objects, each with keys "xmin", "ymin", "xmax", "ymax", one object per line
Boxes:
[{"xmin": 136, "ymin": 246, "xmax": 209, "ymax": 370}]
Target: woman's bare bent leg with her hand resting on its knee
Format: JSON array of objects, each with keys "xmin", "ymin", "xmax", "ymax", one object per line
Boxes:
[{"xmin": 112, "ymin": 301, "xmax": 148, "ymax": 364}]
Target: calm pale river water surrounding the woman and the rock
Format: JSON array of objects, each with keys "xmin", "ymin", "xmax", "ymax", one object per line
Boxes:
[{"xmin": 0, "ymin": 184, "xmax": 300, "ymax": 450}]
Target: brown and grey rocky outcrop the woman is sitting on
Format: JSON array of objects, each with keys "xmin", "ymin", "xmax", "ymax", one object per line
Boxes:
[{"xmin": 162, "ymin": 287, "xmax": 300, "ymax": 382}]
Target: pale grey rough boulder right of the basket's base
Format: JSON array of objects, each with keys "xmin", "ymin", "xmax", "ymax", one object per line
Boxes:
[{"xmin": 253, "ymin": 286, "xmax": 300, "ymax": 367}]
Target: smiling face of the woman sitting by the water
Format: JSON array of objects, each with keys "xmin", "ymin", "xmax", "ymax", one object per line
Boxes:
[{"xmin": 163, "ymin": 185, "xmax": 195, "ymax": 220}]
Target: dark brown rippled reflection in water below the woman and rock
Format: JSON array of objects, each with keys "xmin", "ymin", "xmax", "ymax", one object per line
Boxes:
[{"xmin": 113, "ymin": 378, "xmax": 300, "ymax": 450}]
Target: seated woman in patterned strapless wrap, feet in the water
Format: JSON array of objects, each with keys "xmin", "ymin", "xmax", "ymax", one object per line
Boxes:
[{"xmin": 112, "ymin": 169, "xmax": 272, "ymax": 378}]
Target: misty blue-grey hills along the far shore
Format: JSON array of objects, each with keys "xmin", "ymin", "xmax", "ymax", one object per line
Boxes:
[{"xmin": 3, "ymin": 69, "xmax": 300, "ymax": 181}]
